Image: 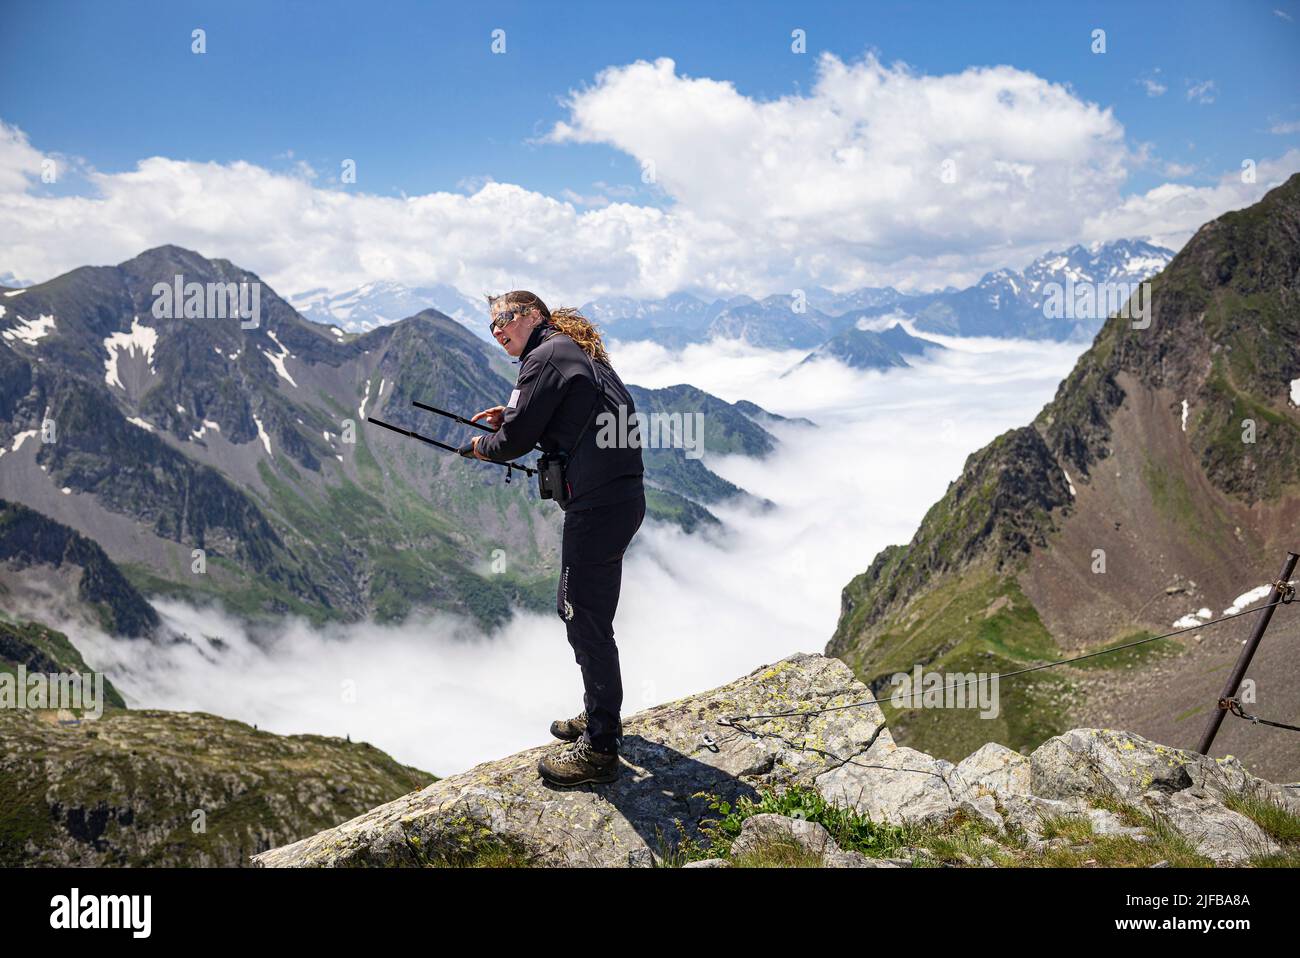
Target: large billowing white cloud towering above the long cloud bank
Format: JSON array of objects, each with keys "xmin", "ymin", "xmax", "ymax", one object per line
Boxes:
[{"xmin": 550, "ymin": 53, "xmax": 1125, "ymax": 274}]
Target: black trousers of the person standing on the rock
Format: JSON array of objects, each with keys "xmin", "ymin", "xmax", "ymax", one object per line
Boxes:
[{"xmin": 555, "ymin": 495, "xmax": 646, "ymax": 751}]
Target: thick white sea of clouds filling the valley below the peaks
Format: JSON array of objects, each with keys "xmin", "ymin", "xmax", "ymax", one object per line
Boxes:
[{"xmin": 64, "ymin": 337, "xmax": 1083, "ymax": 775}]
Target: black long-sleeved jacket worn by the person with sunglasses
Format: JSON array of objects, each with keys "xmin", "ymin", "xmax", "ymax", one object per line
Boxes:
[{"xmin": 478, "ymin": 320, "xmax": 645, "ymax": 511}]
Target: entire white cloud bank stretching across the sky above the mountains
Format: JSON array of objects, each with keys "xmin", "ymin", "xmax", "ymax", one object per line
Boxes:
[{"xmin": 0, "ymin": 53, "xmax": 1294, "ymax": 303}]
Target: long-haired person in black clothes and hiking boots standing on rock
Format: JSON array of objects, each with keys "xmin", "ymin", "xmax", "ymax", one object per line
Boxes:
[{"xmin": 464, "ymin": 290, "xmax": 646, "ymax": 785}]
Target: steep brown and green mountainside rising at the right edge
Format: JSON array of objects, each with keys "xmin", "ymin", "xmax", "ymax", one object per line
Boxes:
[{"xmin": 827, "ymin": 177, "xmax": 1300, "ymax": 769}]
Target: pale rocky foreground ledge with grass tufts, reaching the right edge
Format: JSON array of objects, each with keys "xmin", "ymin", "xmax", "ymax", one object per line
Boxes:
[{"xmin": 254, "ymin": 654, "xmax": 1300, "ymax": 867}]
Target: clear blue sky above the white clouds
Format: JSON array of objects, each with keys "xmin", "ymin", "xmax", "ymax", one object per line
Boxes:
[{"xmin": 0, "ymin": 0, "xmax": 1300, "ymax": 199}]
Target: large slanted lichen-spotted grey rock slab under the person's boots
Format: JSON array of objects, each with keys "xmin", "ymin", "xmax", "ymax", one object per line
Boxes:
[{"xmin": 254, "ymin": 654, "xmax": 894, "ymax": 867}]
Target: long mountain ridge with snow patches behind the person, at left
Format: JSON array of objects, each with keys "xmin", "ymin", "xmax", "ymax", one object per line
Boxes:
[{"xmin": 0, "ymin": 247, "xmax": 762, "ymax": 625}]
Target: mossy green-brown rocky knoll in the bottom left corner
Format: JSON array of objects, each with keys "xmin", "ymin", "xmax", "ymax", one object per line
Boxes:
[{"xmin": 0, "ymin": 686, "xmax": 433, "ymax": 867}]
